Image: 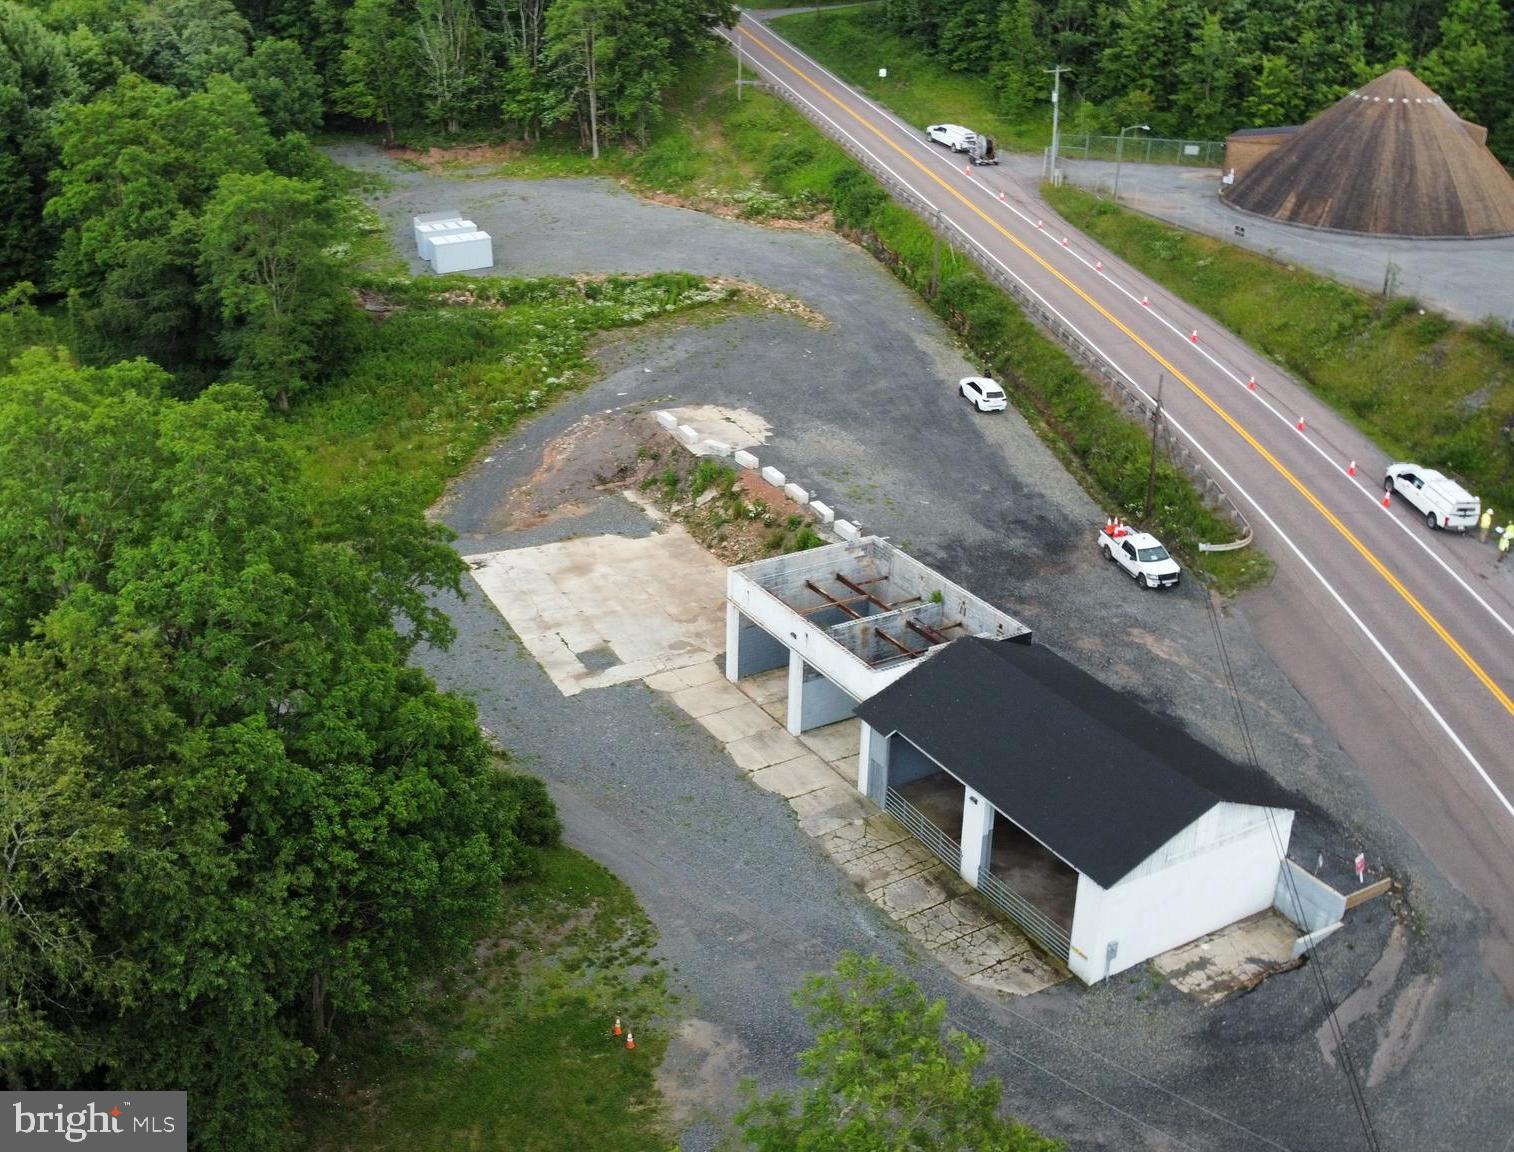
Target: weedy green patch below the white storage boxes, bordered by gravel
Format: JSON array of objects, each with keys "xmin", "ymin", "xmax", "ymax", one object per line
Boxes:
[{"xmin": 288, "ymin": 272, "xmax": 734, "ymax": 500}]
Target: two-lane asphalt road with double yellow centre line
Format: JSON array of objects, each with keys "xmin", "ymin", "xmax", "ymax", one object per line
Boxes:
[{"xmin": 736, "ymin": 15, "xmax": 1514, "ymax": 992}]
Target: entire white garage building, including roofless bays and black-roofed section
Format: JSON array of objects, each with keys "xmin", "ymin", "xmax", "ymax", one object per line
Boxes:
[{"xmin": 725, "ymin": 537, "xmax": 1295, "ymax": 984}]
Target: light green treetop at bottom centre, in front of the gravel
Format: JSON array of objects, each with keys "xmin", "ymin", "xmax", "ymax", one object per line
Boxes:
[{"xmin": 736, "ymin": 952, "xmax": 1061, "ymax": 1152}]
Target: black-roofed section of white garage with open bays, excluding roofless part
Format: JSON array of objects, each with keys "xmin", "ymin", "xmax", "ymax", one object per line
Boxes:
[{"xmin": 857, "ymin": 639, "xmax": 1293, "ymax": 984}]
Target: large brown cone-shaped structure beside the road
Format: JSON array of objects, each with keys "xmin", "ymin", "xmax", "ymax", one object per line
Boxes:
[{"xmin": 1222, "ymin": 68, "xmax": 1514, "ymax": 238}]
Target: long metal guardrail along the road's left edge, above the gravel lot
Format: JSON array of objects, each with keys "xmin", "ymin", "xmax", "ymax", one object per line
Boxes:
[{"xmin": 741, "ymin": 35, "xmax": 1252, "ymax": 551}]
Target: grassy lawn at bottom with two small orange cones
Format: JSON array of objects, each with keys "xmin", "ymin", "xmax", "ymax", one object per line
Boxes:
[{"xmin": 295, "ymin": 848, "xmax": 671, "ymax": 1152}]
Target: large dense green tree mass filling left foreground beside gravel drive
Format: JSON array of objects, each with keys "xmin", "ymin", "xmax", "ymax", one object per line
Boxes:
[{"xmin": 0, "ymin": 351, "xmax": 554, "ymax": 1152}]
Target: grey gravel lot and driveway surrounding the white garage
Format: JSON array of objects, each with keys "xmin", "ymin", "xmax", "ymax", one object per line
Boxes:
[{"xmin": 338, "ymin": 148, "xmax": 1514, "ymax": 1150}]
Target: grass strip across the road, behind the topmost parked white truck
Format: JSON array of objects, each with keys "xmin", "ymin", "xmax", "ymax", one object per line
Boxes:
[{"xmin": 771, "ymin": 5, "xmax": 1053, "ymax": 151}]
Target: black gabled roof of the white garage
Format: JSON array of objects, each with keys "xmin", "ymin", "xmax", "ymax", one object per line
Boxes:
[{"xmin": 857, "ymin": 637, "xmax": 1287, "ymax": 887}]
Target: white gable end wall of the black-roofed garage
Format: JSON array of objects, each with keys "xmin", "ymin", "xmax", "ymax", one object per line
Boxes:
[{"xmin": 1069, "ymin": 804, "xmax": 1293, "ymax": 984}]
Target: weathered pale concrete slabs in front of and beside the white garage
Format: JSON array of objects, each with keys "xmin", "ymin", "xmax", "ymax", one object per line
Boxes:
[{"xmin": 466, "ymin": 498, "xmax": 1295, "ymax": 1001}]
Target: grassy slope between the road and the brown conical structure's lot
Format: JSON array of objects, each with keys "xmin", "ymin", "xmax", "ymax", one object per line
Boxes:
[{"xmin": 1043, "ymin": 186, "xmax": 1514, "ymax": 509}]
